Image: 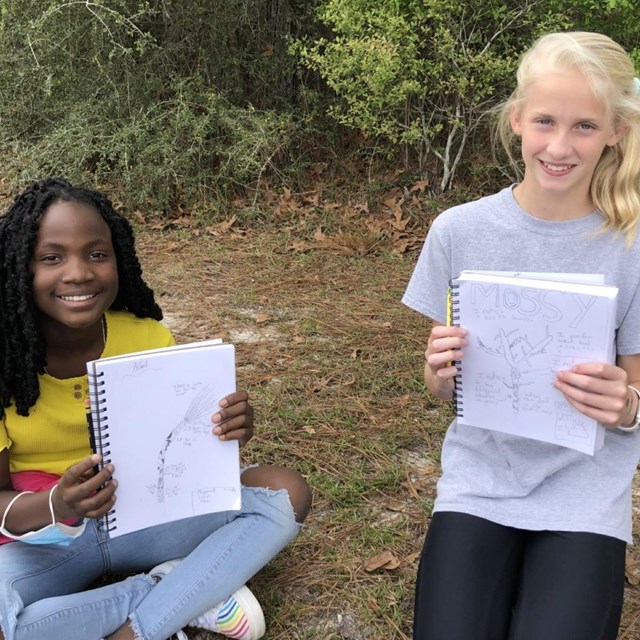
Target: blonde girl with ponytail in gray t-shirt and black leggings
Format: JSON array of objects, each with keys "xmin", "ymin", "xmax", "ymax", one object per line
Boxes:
[{"xmin": 403, "ymin": 32, "xmax": 640, "ymax": 640}]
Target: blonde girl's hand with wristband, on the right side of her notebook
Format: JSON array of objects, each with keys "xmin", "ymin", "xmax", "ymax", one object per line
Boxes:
[{"xmin": 554, "ymin": 362, "xmax": 629, "ymax": 428}]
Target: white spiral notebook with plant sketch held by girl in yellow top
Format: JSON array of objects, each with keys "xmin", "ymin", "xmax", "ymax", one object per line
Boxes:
[{"xmin": 87, "ymin": 340, "xmax": 241, "ymax": 537}]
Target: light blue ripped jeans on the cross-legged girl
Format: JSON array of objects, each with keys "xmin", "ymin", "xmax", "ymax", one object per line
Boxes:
[{"xmin": 0, "ymin": 487, "xmax": 300, "ymax": 640}]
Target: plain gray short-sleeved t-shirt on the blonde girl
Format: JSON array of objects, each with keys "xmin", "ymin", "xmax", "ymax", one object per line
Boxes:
[{"xmin": 402, "ymin": 187, "xmax": 640, "ymax": 542}]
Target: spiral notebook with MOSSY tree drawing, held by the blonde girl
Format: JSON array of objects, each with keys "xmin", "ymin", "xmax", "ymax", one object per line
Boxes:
[{"xmin": 448, "ymin": 271, "xmax": 618, "ymax": 455}]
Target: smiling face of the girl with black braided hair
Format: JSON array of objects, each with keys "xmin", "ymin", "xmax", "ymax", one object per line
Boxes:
[{"xmin": 31, "ymin": 201, "xmax": 118, "ymax": 334}]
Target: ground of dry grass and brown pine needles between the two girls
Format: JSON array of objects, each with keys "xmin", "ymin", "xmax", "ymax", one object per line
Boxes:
[{"xmin": 138, "ymin": 195, "xmax": 640, "ymax": 640}]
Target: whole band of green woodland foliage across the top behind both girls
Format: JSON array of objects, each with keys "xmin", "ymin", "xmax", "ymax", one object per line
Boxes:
[{"xmin": 0, "ymin": 0, "xmax": 640, "ymax": 216}]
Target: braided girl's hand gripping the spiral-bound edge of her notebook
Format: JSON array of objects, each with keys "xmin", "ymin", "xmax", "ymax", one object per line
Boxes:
[{"xmin": 53, "ymin": 454, "xmax": 118, "ymax": 520}]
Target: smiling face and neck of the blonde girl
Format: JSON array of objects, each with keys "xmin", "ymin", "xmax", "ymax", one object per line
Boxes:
[{"xmin": 511, "ymin": 72, "xmax": 622, "ymax": 219}]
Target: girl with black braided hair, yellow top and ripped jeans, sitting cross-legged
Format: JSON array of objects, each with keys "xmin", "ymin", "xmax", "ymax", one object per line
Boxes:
[{"xmin": 0, "ymin": 179, "xmax": 310, "ymax": 640}]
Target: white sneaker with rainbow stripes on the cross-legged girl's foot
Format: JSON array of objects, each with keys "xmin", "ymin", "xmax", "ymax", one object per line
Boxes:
[{"xmin": 189, "ymin": 587, "xmax": 266, "ymax": 640}]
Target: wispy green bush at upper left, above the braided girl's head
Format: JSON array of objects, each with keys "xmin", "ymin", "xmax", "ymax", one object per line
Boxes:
[{"xmin": 0, "ymin": 0, "xmax": 294, "ymax": 211}]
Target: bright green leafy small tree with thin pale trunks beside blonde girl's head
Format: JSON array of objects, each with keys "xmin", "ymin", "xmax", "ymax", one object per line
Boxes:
[{"xmin": 291, "ymin": 0, "xmax": 638, "ymax": 191}]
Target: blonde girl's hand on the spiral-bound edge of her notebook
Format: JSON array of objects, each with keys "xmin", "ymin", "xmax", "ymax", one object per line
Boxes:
[{"xmin": 424, "ymin": 324, "xmax": 467, "ymax": 400}]
